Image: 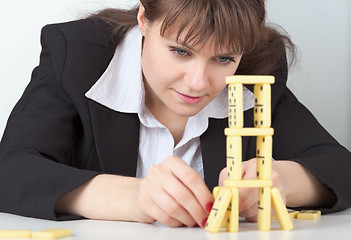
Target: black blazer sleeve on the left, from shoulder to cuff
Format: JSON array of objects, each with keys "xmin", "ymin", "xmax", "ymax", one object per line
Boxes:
[{"xmin": 0, "ymin": 23, "xmax": 99, "ymax": 220}]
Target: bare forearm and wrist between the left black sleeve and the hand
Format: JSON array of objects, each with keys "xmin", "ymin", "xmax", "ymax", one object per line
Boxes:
[{"xmin": 56, "ymin": 174, "xmax": 140, "ymax": 221}]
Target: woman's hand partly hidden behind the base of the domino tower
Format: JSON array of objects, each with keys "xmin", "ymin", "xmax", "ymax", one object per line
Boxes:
[{"xmin": 218, "ymin": 158, "xmax": 286, "ymax": 222}]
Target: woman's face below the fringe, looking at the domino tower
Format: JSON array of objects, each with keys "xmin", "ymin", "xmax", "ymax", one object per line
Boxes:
[{"xmin": 139, "ymin": 8, "xmax": 241, "ymax": 121}]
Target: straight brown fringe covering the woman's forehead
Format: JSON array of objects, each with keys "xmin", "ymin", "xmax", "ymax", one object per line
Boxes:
[{"xmin": 145, "ymin": 0, "xmax": 265, "ymax": 54}]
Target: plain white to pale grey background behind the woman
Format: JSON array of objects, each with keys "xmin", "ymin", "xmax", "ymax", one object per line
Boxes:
[{"xmin": 0, "ymin": 0, "xmax": 351, "ymax": 150}]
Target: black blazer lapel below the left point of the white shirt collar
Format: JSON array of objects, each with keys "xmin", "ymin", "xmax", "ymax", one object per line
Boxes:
[{"xmin": 89, "ymin": 100, "xmax": 140, "ymax": 177}]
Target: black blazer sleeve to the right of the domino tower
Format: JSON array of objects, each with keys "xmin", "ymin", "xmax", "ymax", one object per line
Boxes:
[{"xmin": 272, "ymin": 56, "xmax": 351, "ymax": 213}]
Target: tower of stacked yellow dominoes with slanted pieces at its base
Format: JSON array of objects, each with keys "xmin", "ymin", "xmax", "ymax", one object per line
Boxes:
[{"xmin": 205, "ymin": 75, "xmax": 293, "ymax": 233}]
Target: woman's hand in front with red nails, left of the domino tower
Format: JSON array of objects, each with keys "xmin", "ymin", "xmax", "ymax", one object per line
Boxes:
[{"xmin": 136, "ymin": 156, "xmax": 214, "ymax": 227}]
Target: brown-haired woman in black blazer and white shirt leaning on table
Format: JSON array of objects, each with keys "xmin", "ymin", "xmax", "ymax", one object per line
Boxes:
[{"xmin": 0, "ymin": 0, "xmax": 351, "ymax": 227}]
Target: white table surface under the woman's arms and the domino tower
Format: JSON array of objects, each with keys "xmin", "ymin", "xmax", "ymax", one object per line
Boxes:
[{"xmin": 0, "ymin": 209, "xmax": 351, "ymax": 240}]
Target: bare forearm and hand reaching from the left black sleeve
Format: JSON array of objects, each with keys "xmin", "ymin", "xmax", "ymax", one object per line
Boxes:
[{"xmin": 56, "ymin": 157, "xmax": 213, "ymax": 227}]
